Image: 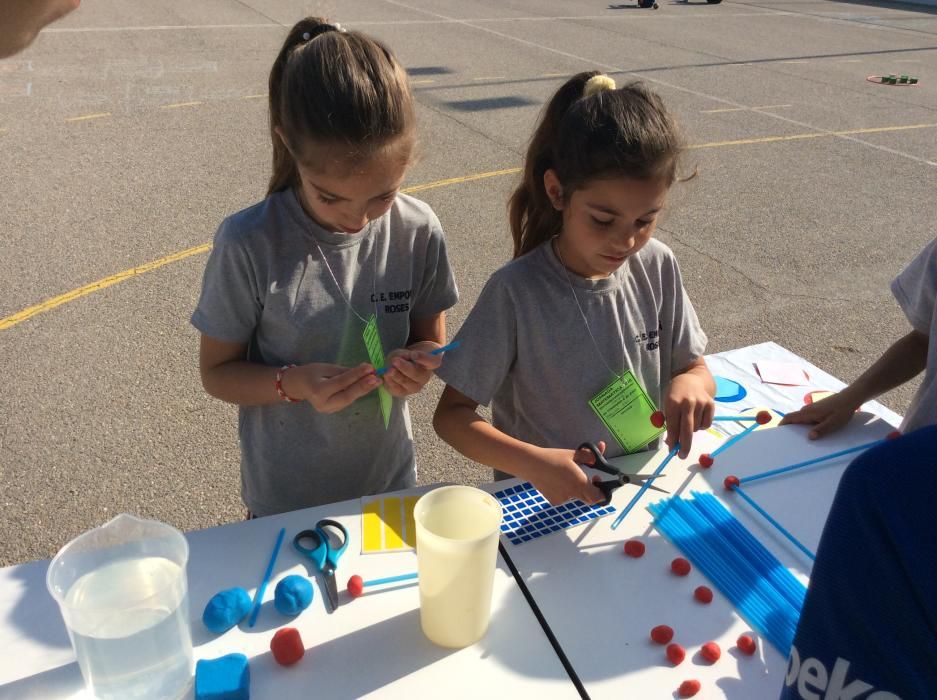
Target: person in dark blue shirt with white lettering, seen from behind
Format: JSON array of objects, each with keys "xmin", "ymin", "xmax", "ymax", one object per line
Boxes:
[{"xmin": 781, "ymin": 426, "xmax": 937, "ymax": 700}]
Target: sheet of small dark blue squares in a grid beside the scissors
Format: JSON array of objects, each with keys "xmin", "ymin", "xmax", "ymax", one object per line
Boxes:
[{"xmin": 494, "ymin": 482, "xmax": 615, "ymax": 544}]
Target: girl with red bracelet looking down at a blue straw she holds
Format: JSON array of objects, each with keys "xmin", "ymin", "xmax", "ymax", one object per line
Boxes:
[{"xmin": 192, "ymin": 18, "xmax": 458, "ymax": 515}]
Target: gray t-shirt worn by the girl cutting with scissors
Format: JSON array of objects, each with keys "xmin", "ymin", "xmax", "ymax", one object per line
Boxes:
[{"xmin": 437, "ymin": 239, "xmax": 706, "ymax": 477}]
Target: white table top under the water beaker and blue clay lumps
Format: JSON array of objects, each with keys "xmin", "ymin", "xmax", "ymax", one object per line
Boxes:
[{"xmin": 0, "ymin": 492, "xmax": 579, "ymax": 700}]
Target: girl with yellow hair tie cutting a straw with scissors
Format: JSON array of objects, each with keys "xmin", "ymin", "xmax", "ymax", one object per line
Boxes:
[{"xmin": 434, "ymin": 72, "xmax": 715, "ymax": 504}]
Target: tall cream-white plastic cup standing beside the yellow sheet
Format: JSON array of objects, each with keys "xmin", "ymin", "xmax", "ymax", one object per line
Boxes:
[{"xmin": 413, "ymin": 486, "xmax": 501, "ymax": 648}]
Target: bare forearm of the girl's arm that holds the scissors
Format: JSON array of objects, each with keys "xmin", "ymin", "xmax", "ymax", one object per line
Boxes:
[{"xmin": 433, "ymin": 405, "xmax": 538, "ymax": 480}]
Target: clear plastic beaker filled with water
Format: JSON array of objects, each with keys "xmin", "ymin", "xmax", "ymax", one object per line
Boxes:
[{"xmin": 46, "ymin": 513, "xmax": 192, "ymax": 700}]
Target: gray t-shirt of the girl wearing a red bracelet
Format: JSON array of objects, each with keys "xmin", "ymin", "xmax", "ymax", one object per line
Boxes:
[{"xmin": 192, "ymin": 191, "xmax": 458, "ymax": 515}]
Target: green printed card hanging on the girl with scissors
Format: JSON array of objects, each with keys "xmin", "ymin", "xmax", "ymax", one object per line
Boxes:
[{"xmin": 589, "ymin": 369, "xmax": 665, "ymax": 453}]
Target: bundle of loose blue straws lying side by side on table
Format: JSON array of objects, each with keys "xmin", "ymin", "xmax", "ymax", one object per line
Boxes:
[{"xmin": 648, "ymin": 492, "xmax": 806, "ymax": 655}]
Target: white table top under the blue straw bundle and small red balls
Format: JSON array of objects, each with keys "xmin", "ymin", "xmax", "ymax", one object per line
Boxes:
[{"xmin": 492, "ymin": 343, "xmax": 898, "ymax": 700}]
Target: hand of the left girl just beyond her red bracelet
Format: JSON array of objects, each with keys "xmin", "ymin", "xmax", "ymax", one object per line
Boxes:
[{"xmin": 282, "ymin": 362, "xmax": 382, "ymax": 413}]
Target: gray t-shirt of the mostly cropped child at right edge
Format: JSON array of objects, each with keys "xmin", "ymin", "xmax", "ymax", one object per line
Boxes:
[{"xmin": 891, "ymin": 239, "xmax": 937, "ymax": 433}]
